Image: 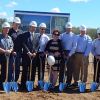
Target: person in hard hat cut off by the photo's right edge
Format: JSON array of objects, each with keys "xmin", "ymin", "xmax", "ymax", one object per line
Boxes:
[{"xmin": 91, "ymin": 28, "xmax": 100, "ymax": 86}]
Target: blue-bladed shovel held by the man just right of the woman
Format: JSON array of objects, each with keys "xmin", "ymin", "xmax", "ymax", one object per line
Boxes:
[{"xmin": 59, "ymin": 59, "xmax": 68, "ymax": 91}]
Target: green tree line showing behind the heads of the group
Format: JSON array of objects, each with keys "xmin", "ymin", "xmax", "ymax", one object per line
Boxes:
[{"xmin": 0, "ymin": 18, "xmax": 97, "ymax": 40}]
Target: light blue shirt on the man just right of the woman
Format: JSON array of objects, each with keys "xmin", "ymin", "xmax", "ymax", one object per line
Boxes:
[{"xmin": 60, "ymin": 32, "xmax": 77, "ymax": 56}]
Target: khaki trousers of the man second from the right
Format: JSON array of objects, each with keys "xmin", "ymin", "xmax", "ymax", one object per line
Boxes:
[{"xmin": 73, "ymin": 53, "xmax": 89, "ymax": 83}]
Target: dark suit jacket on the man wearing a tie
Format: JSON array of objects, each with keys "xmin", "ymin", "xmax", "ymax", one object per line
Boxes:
[{"xmin": 22, "ymin": 32, "xmax": 39, "ymax": 54}]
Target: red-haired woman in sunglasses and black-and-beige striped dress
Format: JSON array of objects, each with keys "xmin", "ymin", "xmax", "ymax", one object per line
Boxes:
[{"xmin": 45, "ymin": 29, "xmax": 63, "ymax": 89}]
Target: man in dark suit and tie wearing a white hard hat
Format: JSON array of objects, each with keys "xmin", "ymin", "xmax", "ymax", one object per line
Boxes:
[{"xmin": 21, "ymin": 21, "xmax": 39, "ymax": 89}]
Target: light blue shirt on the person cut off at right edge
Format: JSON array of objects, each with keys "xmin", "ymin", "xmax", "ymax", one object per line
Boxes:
[{"xmin": 91, "ymin": 38, "xmax": 100, "ymax": 55}]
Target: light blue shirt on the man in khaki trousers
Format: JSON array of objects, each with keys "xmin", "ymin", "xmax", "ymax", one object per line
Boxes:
[{"xmin": 76, "ymin": 35, "xmax": 92, "ymax": 56}]
